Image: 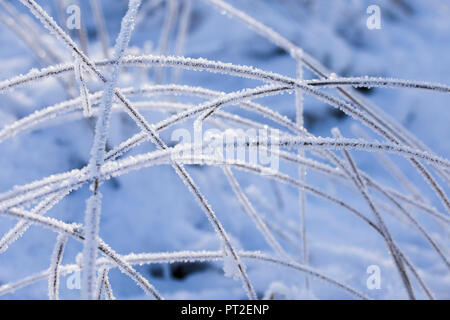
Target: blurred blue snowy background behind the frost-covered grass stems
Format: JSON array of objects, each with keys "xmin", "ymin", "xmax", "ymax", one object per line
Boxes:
[{"xmin": 0, "ymin": 0, "xmax": 450, "ymax": 299}]
